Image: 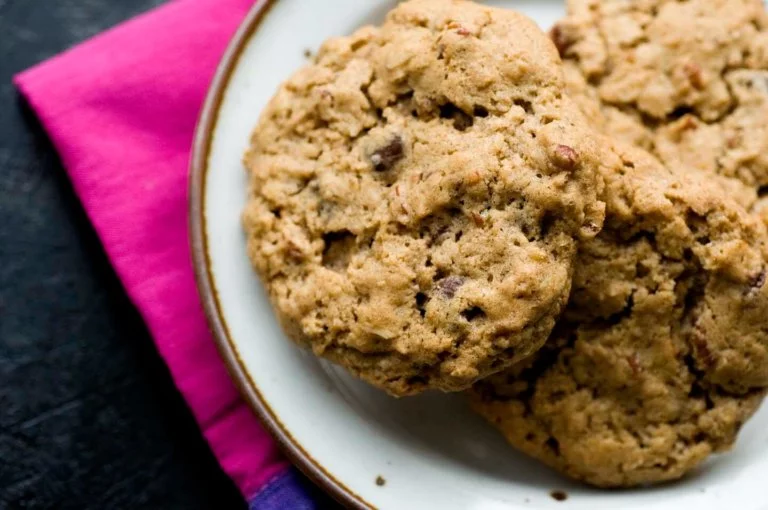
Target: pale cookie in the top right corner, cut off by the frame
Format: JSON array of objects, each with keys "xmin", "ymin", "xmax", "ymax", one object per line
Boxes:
[{"xmin": 551, "ymin": 0, "xmax": 768, "ymax": 189}]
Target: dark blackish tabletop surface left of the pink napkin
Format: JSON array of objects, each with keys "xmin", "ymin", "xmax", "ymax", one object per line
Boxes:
[{"xmin": 0, "ymin": 0, "xmax": 248, "ymax": 509}]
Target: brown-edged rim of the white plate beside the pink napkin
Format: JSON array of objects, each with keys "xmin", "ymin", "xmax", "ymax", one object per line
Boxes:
[{"xmin": 187, "ymin": 0, "xmax": 375, "ymax": 510}]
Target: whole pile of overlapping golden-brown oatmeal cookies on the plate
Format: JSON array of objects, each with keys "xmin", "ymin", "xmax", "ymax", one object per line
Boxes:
[{"xmin": 244, "ymin": 0, "xmax": 768, "ymax": 487}]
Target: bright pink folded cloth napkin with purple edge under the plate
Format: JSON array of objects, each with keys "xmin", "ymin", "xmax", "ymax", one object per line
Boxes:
[{"xmin": 14, "ymin": 0, "xmax": 316, "ymax": 510}]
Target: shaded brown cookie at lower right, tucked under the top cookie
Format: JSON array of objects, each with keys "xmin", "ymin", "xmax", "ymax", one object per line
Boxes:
[{"xmin": 473, "ymin": 142, "xmax": 768, "ymax": 487}]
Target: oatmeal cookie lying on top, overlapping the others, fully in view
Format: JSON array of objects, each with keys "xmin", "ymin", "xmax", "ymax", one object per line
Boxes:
[{"xmin": 244, "ymin": 0, "xmax": 604, "ymax": 395}]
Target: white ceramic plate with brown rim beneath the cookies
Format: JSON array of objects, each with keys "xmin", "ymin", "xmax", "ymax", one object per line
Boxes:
[{"xmin": 191, "ymin": 0, "xmax": 768, "ymax": 510}]
